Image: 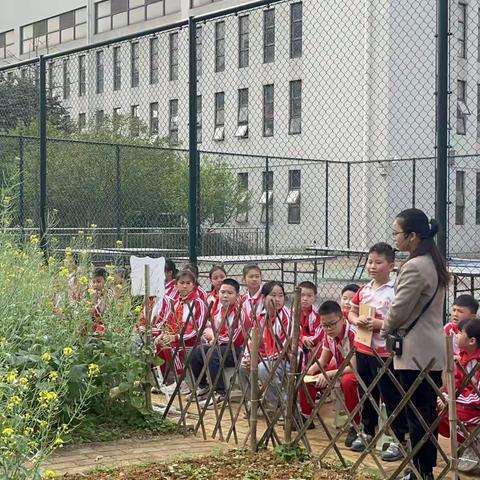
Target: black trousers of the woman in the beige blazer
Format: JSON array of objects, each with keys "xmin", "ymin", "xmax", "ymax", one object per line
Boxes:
[{"xmin": 398, "ymin": 370, "xmax": 442, "ymax": 475}]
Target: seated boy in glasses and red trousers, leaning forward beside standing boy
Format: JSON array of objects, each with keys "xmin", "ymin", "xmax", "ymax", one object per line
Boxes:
[{"xmin": 298, "ymin": 300, "xmax": 360, "ymax": 447}]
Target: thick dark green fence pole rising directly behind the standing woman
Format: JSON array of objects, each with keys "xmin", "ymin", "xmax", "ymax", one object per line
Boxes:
[{"xmin": 435, "ymin": 0, "xmax": 449, "ymax": 257}]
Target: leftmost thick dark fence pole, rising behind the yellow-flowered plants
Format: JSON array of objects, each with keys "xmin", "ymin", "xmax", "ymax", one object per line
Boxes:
[{"xmin": 38, "ymin": 55, "xmax": 48, "ymax": 259}]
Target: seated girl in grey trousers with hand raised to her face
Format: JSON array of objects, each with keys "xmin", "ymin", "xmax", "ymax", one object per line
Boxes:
[{"xmin": 239, "ymin": 282, "xmax": 291, "ymax": 411}]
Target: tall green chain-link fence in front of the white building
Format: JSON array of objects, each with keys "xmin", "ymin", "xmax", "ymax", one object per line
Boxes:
[{"xmin": 0, "ymin": 0, "xmax": 480, "ymax": 300}]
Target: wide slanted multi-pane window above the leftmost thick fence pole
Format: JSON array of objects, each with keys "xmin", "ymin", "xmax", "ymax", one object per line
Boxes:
[{"xmin": 20, "ymin": 7, "xmax": 87, "ymax": 53}]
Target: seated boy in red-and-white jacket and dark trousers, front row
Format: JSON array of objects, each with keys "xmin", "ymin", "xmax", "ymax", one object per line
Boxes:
[{"xmin": 190, "ymin": 278, "xmax": 249, "ymax": 408}]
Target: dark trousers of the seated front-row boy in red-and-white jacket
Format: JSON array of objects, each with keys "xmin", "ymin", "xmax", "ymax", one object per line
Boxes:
[{"xmin": 190, "ymin": 345, "xmax": 241, "ymax": 393}]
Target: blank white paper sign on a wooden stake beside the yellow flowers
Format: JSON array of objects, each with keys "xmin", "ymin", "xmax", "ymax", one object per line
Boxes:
[{"xmin": 130, "ymin": 255, "xmax": 165, "ymax": 298}]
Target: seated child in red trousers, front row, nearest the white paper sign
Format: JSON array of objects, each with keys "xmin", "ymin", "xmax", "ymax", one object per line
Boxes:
[{"xmin": 152, "ymin": 270, "xmax": 206, "ymax": 393}]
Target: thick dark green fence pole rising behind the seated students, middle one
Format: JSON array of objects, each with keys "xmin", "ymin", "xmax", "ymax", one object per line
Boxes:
[{"xmin": 188, "ymin": 17, "xmax": 199, "ymax": 263}]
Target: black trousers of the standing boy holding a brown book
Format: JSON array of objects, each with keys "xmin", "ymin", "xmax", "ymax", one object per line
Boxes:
[{"xmin": 355, "ymin": 352, "xmax": 408, "ymax": 442}]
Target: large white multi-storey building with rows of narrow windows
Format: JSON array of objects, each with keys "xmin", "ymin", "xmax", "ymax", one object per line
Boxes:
[{"xmin": 0, "ymin": 0, "xmax": 480, "ymax": 253}]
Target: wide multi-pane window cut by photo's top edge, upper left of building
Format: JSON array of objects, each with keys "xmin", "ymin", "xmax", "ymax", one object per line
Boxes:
[{"xmin": 95, "ymin": 0, "xmax": 168, "ymax": 33}]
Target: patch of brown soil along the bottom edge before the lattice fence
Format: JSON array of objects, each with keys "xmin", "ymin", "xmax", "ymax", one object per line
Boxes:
[{"xmin": 66, "ymin": 450, "xmax": 371, "ymax": 480}]
